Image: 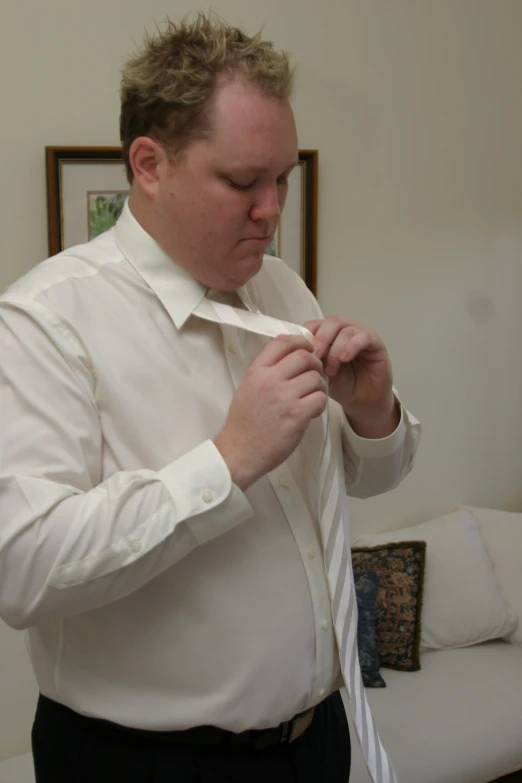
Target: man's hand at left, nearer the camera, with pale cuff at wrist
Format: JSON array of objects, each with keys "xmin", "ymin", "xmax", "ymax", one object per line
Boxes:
[{"xmin": 214, "ymin": 335, "xmax": 327, "ymax": 490}]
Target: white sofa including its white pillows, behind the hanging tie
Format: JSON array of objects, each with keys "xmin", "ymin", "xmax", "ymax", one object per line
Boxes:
[{"xmin": 350, "ymin": 508, "xmax": 522, "ymax": 783}]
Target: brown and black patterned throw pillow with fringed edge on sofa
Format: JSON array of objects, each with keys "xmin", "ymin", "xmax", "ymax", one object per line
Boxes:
[{"xmin": 352, "ymin": 541, "xmax": 426, "ymax": 672}]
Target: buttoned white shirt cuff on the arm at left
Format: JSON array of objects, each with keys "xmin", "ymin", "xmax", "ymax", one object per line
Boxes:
[{"xmin": 158, "ymin": 440, "xmax": 254, "ymax": 544}]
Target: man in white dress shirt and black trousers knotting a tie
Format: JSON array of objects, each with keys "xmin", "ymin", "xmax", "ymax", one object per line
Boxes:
[{"xmin": 0, "ymin": 15, "xmax": 418, "ymax": 783}]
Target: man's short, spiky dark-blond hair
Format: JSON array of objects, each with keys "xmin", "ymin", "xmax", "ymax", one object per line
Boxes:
[{"xmin": 120, "ymin": 13, "xmax": 293, "ymax": 182}]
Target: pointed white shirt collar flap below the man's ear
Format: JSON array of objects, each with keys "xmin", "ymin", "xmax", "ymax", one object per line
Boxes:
[{"xmin": 114, "ymin": 202, "xmax": 211, "ymax": 329}]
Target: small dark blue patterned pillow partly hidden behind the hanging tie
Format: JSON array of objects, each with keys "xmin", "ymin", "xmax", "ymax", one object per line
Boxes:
[{"xmin": 353, "ymin": 571, "xmax": 386, "ymax": 688}]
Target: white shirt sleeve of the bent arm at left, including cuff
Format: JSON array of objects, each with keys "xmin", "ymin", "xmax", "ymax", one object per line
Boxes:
[{"xmin": 0, "ymin": 301, "xmax": 252, "ymax": 628}]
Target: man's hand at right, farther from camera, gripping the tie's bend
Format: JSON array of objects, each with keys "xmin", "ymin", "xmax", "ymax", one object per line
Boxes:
[{"xmin": 305, "ymin": 316, "xmax": 399, "ymax": 438}]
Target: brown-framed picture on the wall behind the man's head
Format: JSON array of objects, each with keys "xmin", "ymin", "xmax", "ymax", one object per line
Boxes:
[{"xmin": 45, "ymin": 147, "xmax": 318, "ymax": 294}]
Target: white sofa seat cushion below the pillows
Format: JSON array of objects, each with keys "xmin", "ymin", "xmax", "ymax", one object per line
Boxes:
[{"xmin": 350, "ymin": 641, "xmax": 522, "ymax": 783}]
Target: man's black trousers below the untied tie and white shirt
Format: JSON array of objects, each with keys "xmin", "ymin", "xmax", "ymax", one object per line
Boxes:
[{"xmin": 32, "ymin": 693, "xmax": 350, "ymax": 783}]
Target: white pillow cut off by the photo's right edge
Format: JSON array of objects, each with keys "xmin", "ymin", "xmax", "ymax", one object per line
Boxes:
[{"xmin": 469, "ymin": 506, "xmax": 522, "ymax": 646}]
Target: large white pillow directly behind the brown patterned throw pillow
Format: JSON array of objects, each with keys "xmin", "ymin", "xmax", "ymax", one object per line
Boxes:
[{"xmin": 354, "ymin": 508, "xmax": 518, "ymax": 650}]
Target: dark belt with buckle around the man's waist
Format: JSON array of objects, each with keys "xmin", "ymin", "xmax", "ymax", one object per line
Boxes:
[{"xmin": 110, "ymin": 707, "xmax": 315, "ymax": 750}]
